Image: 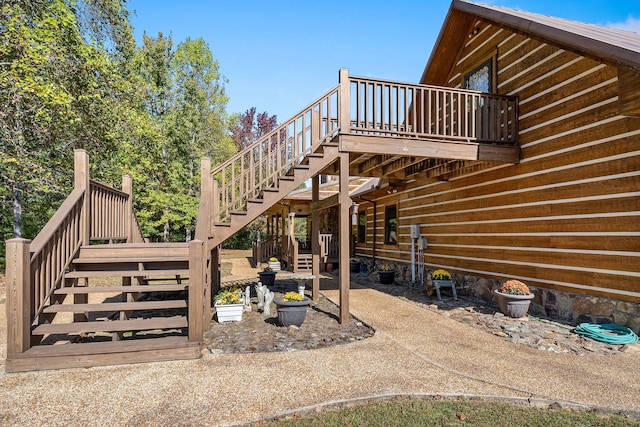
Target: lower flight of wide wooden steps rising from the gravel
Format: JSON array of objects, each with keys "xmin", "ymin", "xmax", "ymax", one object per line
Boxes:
[{"xmin": 7, "ymin": 243, "xmax": 200, "ymax": 372}]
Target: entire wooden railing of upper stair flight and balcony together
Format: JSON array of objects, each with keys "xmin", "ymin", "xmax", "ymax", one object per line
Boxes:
[{"xmin": 212, "ymin": 69, "xmax": 518, "ymax": 227}]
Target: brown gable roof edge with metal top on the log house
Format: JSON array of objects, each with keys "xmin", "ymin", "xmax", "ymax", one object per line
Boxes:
[{"xmin": 420, "ymin": 0, "xmax": 640, "ymax": 85}]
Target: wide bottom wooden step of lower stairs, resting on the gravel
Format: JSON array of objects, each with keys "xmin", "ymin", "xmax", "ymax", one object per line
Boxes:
[{"xmin": 5, "ymin": 337, "xmax": 201, "ymax": 372}]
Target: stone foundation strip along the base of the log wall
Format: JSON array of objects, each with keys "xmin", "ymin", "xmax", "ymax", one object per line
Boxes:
[{"xmin": 360, "ymin": 258, "xmax": 640, "ymax": 334}]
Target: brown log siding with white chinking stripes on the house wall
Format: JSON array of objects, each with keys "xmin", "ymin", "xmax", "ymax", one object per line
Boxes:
[{"xmin": 357, "ymin": 18, "xmax": 640, "ymax": 302}]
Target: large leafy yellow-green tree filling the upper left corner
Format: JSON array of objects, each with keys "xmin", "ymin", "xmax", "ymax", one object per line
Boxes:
[{"xmin": 0, "ymin": 0, "xmax": 145, "ymax": 264}]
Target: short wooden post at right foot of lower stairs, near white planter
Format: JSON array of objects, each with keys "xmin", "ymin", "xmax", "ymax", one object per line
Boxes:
[{"xmin": 189, "ymin": 239, "xmax": 204, "ymax": 343}]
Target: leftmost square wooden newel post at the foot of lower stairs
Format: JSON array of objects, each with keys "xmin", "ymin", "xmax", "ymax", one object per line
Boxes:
[{"xmin": 6, "ymin": 238, "xmax": 32, "ymax": 358}]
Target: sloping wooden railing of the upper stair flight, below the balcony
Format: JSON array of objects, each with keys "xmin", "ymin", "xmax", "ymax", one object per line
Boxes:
[{"xmin": 211, "ymin": 83, "xmax": 348, "ymax": 222}]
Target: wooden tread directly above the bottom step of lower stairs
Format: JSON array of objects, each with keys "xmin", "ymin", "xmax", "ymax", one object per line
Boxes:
[{"xmin": 32, "ymin": 316, "xmax": 188, "ymax": 335}]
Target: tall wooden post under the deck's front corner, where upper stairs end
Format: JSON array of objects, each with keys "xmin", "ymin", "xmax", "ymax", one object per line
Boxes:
[{"xmin": 338, "ymin": 153, "xmax": 351, "ymax": 324}]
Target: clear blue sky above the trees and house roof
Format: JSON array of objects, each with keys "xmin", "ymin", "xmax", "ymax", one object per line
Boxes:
[{"xmin": 129, "ymin": 0, "xmax": 640, "ymax": 122}]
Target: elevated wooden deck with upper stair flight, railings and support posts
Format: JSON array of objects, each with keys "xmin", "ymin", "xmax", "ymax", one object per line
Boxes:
[{"xmin": 208, "ymin": 69, "xmax": 520, "ymax": 328}]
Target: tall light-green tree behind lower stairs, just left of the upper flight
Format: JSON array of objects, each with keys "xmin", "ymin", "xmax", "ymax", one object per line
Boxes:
[{"xmin": 128, "ymin": 33, "xmax": 235, "ymax": 241}]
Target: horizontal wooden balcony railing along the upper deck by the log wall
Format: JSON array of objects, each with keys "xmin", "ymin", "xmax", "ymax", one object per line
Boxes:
[{"xmin": 349, "ymin": 77, "xmax": 517, "ymax": 144}]
